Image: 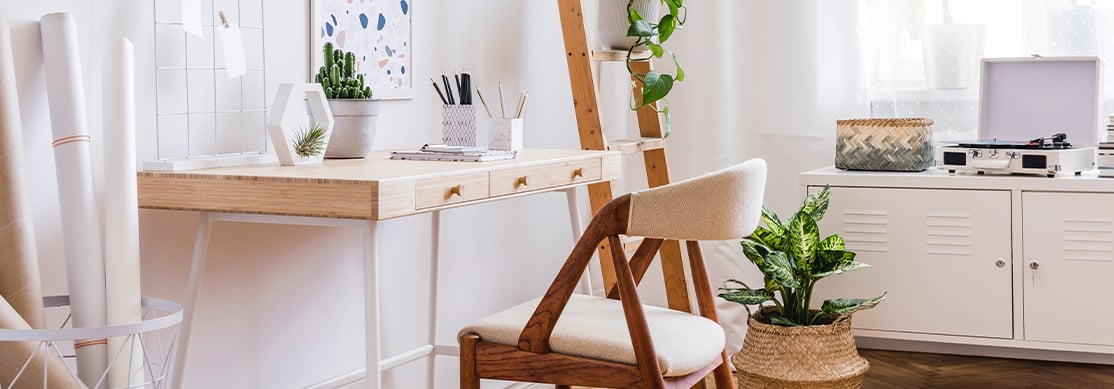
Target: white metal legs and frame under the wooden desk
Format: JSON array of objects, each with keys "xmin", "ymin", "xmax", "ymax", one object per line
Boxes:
[{"xmin": 140, "ymin": 149, "xmax": 617, "ymax": 389}]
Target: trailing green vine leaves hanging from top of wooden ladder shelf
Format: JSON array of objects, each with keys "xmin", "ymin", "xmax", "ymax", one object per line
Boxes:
[{"xmin": 626, "ymin": 0, "xmax": 688, "ymax": 137}]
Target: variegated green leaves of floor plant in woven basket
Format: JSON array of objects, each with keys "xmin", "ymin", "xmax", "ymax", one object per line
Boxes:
[{"xmin": 720, "ymin": 187, "xmax": 886, "ymax": 325}]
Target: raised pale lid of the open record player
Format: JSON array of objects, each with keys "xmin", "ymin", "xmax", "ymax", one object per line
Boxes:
[{"xmin": 979, "ymin": 57, "xmax": 1103, "ymax": 146}]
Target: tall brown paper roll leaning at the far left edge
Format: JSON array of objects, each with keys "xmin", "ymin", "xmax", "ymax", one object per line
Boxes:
[{"xmin": 0, "ymin": 0, "xmax": 43, "ymax": 329}]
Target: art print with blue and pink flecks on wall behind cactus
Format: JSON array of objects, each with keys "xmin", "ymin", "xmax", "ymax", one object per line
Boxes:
[{"xmin": 310, "ymin": 0, "xmax": 413, "ymax": 99}]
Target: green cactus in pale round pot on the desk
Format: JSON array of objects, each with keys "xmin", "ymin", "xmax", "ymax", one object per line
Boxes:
[{"xmin": 314, "ymin": 42, "xmax": 379, "ymax": 158}]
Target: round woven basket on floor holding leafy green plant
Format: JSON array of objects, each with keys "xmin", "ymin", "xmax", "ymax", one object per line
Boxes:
[{"xmin": 731, "ymin": 307, "xmax": 870, "ymax": 389}]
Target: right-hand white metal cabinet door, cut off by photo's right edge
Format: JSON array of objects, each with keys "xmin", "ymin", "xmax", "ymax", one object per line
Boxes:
[{"xmin": 1022, "ymin": 192, "xmax": 1114, "ymax": 344}]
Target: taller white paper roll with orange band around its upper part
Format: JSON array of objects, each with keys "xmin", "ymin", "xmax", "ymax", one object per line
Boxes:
[{"xmin": 39, "ymin": 12, "xmax": 108, "ymax": 386}]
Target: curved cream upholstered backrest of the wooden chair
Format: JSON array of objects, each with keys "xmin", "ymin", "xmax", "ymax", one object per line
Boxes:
[{"xmin": 626, "ymin": 158, "xmax": 766, "ymax": 241}]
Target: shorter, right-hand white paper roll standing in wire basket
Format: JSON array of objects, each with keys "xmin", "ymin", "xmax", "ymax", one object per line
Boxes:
[{"xmin": 102, "ymin": 38, "xmax": 144, "ymax": 388}]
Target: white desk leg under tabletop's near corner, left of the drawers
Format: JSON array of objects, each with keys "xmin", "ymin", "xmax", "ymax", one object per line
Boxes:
[{"xmin": 363, "ymin": 221, "xmax": 383, "ymax": 389}]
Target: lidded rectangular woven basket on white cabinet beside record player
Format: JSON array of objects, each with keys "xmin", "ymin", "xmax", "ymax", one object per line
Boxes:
[{"xmin": 836, "ymin": 118, "xmax": 932, "ymax": 172}]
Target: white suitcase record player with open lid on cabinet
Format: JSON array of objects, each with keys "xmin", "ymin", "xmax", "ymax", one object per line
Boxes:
[{"xmin": 936, "ymin": 57, "xmax": 1102, "ymax": 177}]
